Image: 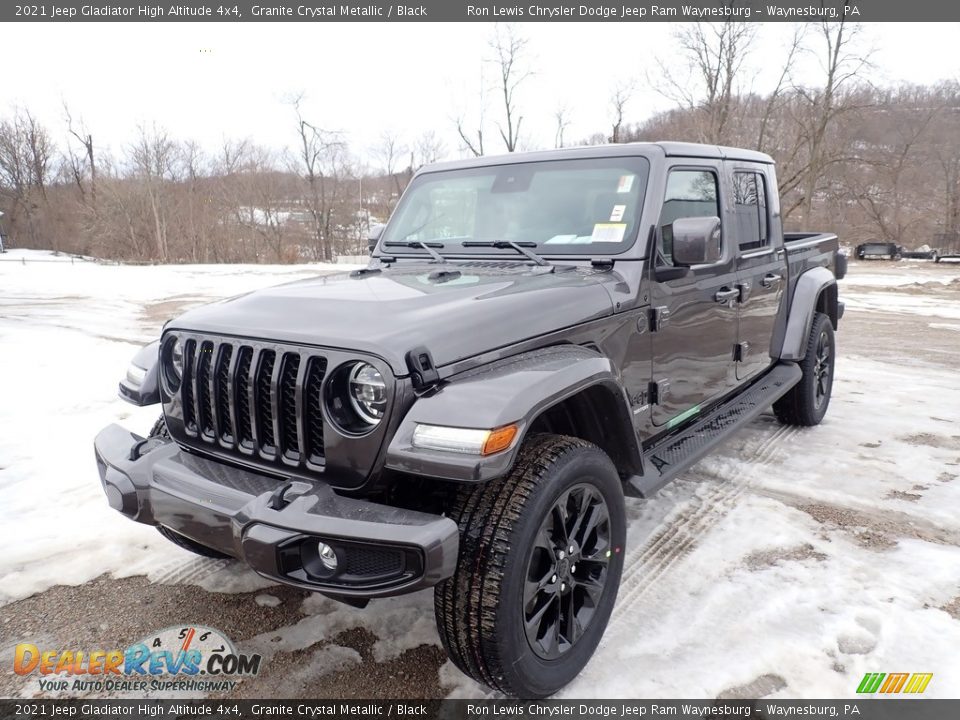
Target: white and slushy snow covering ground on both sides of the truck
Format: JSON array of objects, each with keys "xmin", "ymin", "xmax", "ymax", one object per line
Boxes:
[{"xmin": 0, "ymin": 256, "xmax": 960, "ymax": 698}]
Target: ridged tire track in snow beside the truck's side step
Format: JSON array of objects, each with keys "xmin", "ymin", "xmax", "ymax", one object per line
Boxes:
[{"xmin": 611, "ymin": 426, "xmax": 799, "ymax": 623}]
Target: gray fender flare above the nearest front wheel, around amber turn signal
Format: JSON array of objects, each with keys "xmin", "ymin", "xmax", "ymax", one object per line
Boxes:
[{"xmin": 386, "ymin": 345, "xmax": 639, "ymax": 482}]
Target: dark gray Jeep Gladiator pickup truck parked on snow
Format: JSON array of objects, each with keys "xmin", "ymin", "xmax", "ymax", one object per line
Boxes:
[{"xmin": 96, "ymin": 143, "xmax": 846, "ymax": 697}]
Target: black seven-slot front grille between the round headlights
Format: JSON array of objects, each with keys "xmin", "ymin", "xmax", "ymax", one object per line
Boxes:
[{"xmin": 180, "ymin": 339, "xmax": 327, "ymax": 466}]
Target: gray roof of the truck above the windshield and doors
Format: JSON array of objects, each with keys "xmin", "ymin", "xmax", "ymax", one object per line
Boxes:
[{"xmin": 420, "ymin": 142, "xmax": 773, "ymax": 172}]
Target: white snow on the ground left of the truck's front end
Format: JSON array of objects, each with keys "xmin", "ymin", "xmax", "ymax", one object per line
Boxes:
[{"xmin": 0, "ymin": 250, "xmax": 360, "ymax": 604}]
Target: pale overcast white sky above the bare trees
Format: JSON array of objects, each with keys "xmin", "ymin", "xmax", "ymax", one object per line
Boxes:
[{"xmin": 0, "ymin": 22, "xmax": 960, "ymax": 170}]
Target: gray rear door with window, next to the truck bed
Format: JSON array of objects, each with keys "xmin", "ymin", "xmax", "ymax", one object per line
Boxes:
[{"xmin": 729, "ymin": 164, "xmax": 787, "ymax": 381}]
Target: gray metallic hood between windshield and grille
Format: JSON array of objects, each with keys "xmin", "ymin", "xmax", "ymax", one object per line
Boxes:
[{"xmin": 168, "ymin": 261, "xmax": 613, "ymax": 375}]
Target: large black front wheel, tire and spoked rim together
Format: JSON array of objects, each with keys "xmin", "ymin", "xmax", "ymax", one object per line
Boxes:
[{"xmin": 434, "ymin": 435, "xmax": 626, "ymax": 698}]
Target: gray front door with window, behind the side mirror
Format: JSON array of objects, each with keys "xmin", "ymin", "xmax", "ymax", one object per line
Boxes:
[{"xmin": 650, "ymin": 162, "xmax": 738, "ymax": 429}]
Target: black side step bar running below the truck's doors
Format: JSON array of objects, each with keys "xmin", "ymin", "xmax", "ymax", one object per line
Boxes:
[{"xmin": 625, "ymin": 362, "xmax": 803, "ymax": 497}]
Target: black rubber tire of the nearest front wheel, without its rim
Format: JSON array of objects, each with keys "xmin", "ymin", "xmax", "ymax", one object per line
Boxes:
[{"xmin": 434, "ymin": 435, "xmax": 626, "ymax": 698}]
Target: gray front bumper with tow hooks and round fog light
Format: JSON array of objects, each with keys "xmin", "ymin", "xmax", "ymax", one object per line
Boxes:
[{"xmin": 94, "ymin": 425, "xmax": 459, "ymax": 598}]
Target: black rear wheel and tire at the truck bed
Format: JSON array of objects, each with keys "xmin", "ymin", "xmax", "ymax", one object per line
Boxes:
[{"xmin": 773, "ymin": 313, "xmax": 836, "ymax": 426}]
